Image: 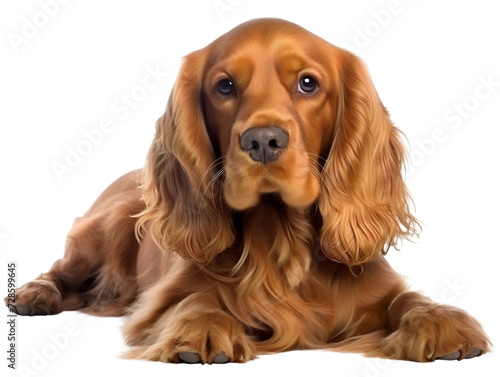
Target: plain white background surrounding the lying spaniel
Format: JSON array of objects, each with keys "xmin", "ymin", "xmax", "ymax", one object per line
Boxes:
[{"xmin": 0, "ymin": 0, "xmax": 500, "ymax": 377}]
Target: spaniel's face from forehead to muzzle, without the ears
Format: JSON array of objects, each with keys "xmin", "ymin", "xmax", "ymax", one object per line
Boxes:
[{"xmin": 202, "ymin": 21, "xmax": 338, "ymax": 210}]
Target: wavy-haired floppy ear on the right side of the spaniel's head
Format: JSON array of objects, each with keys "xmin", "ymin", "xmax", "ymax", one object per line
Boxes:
[{"xmin": 318, "ymin": 51, "xmax": 419, "ymax": 266}]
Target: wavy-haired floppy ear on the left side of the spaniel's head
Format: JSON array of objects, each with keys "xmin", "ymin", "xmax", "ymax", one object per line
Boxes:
[{"xmin": 136, "ymin": 50, "xmax": 234, "ymax": 264}]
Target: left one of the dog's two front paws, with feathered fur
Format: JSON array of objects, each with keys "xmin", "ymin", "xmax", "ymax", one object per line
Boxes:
[{"xmin": 125, "ymin": 292, "xmax": 256, "ymax": 364}]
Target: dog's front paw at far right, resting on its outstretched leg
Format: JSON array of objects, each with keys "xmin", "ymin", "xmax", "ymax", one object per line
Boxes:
[{"xmin": 381, "ymin": 303, "xmax": 490, "ymax": 362}]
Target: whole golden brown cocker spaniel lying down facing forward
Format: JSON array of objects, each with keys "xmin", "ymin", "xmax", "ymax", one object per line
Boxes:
[{"xmin": 7, "ymin": 19, "xmax": 489, "ymax": 363}]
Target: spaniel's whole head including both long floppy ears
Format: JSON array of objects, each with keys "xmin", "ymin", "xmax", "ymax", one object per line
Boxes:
[{"xmin": 139, "ymin": 19, "xmax": 416, "ymax": 265}]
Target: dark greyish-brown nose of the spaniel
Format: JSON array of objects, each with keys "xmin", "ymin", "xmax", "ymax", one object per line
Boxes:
[{"xmin": 240, "ymin": 126, "xmax": 288, "ymax": 164}]
